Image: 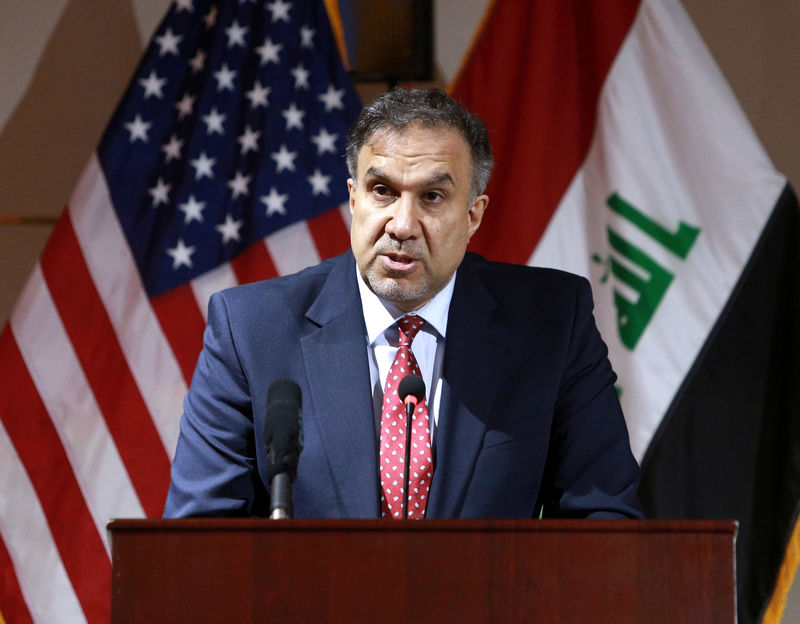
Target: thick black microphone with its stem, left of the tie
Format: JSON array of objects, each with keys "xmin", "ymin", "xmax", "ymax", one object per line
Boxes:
[{"xmin": 264, "ymin": 379, "xmax": 303, "ymax": 519}]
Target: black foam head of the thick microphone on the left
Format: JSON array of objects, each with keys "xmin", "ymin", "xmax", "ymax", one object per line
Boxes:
[{"xmin": 264, "ymin": 379, "xmax": 303, "ymax": 480}]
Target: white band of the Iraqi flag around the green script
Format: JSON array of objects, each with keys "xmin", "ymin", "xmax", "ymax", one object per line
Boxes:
[{"xmin": 530, "ymin": 0, "xmax": 785, "ymax": 460}]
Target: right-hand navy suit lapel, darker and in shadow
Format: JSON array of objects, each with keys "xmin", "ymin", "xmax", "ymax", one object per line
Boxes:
[{"xmin": 426, "ymin": 258, "xmax": 508, "ymax": 518}]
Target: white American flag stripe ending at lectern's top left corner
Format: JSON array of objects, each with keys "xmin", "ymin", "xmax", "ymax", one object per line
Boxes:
[{"xmin": 10, "ymin": 264, "xmax": 144, "ymax": 552}]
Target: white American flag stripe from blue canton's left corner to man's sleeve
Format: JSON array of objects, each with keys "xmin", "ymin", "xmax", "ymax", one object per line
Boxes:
[{"xmin": 69, "ymin": 155, "xmax": 186, "ymax": 458}]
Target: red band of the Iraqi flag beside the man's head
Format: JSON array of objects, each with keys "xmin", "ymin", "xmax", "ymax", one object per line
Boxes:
[{"xmin": 452, "ymin": 0, "xmax": 639, "ymax": 263}]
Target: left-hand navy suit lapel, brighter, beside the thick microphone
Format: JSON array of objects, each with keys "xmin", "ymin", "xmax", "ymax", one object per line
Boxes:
[{"xmin": 300, "ymin": 253, "xmax": 379, "ymax": 518}]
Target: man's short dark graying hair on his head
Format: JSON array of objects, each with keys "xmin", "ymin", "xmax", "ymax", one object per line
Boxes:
[{"xmin": 346, "ymin": 88, "xmax": 494, "ymax": 198}]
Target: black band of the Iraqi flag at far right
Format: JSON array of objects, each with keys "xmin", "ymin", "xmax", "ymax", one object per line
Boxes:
[{"xmin": 639, "ymin": 184, "xmax": 800, "ymax": 624}]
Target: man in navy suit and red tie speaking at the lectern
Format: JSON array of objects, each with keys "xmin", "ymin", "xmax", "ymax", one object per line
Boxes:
[{"xmin": 165, "ymin": 89, "xmax": 641, "ymax": 518}]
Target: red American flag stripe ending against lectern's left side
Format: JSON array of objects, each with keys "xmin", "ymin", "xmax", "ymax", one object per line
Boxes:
[{"xmin": 0, "ymin": 326, "xmax": 111, "ymax": 623}]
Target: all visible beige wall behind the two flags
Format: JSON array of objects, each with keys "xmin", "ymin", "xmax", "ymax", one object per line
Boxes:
[{"xmin": 0, "ymin": 0, "xmax": 800, "ymax": 623}]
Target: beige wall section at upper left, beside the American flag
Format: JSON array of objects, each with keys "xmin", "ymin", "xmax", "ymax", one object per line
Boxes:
[{"xmin": 0, "ymin": 0, "xmax": 155, "ymax": 324}]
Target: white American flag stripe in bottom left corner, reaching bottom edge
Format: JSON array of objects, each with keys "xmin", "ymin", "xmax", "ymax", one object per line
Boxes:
[{"xmin": 0, "ymin": 421, "xmax": 86, "ymax": 624}]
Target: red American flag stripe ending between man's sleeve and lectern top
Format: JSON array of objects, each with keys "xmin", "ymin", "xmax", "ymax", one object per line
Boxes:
[{"xmin": 41, "ymin": 212, "xmax": 170, "ymax": 517}]
